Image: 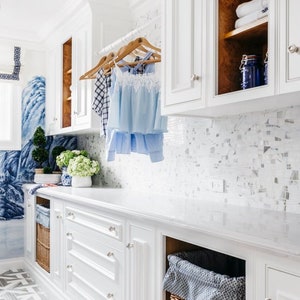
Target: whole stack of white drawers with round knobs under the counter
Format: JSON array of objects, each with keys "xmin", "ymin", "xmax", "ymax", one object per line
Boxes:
[{"xmin": 65, "ymin": 206, "xmax": 125, "ymax": 300}]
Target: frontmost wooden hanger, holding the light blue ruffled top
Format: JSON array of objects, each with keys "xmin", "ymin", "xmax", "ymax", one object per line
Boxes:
[{"xmin": 102, "ymin": 37, "xmax": 161, "ymax": 74}]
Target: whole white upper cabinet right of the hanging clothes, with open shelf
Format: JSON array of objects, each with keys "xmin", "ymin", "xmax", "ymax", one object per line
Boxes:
[{"xmin": 162, "ymin": 0, "xmax": 300, "ymax": 117}]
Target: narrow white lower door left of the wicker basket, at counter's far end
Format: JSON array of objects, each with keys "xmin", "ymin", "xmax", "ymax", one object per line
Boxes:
[{"xmin": 24, "ymin": 190, "xmax": 35, "ymax": 263}]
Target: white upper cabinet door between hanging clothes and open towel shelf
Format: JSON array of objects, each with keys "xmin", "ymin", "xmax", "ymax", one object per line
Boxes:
[{"xmin": 162, "ymin": 0, "xmax": 204, "ymax": 113}]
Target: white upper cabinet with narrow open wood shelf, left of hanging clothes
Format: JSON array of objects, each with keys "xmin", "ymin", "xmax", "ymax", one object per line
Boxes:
[{"xmin": 46, "ymin": 6, "xmax": 99, "ymax": 135}]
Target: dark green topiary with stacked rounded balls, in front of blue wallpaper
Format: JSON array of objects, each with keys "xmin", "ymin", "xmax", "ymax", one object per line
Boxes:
[{"xmin": 31, "ymin": 126, "xmax": 49, "ymax": 174}]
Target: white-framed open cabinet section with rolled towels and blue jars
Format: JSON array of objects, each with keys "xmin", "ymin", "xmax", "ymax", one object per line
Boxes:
[{"xmin": 206, "ymin": 0, "xmax": 276, "ymax": 111}]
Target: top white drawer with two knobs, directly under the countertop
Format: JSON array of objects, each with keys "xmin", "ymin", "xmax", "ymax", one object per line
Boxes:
[{"xmin": 66, "ymin": 207, "xmax": 124, "ymax": 241}]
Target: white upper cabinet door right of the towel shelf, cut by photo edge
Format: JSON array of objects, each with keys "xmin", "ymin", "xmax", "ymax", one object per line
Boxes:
[{"xmin": 278, "ymin": 0, "xmax": 300, "ymax": 93}]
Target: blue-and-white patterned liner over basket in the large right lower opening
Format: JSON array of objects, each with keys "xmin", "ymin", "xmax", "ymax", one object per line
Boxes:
[{"xmin": 163, "ymin": 254, "xmax": 245, "ymax": 300}]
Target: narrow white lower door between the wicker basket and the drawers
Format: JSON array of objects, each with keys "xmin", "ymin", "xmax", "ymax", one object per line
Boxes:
[{"xmin": 50, "ymin": 200, "xmax": 65, "ymax": 288}]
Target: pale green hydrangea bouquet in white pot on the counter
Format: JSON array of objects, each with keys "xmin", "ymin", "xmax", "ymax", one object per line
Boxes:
[{"xmin": 68, "ymin": 155, "xmax": 100, "ymax": 187}]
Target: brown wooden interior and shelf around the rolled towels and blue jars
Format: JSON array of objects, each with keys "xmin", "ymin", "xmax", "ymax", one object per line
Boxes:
[{"xmin": 216, "ymin": 0, "xmax": 268, "ymax": 95}]
